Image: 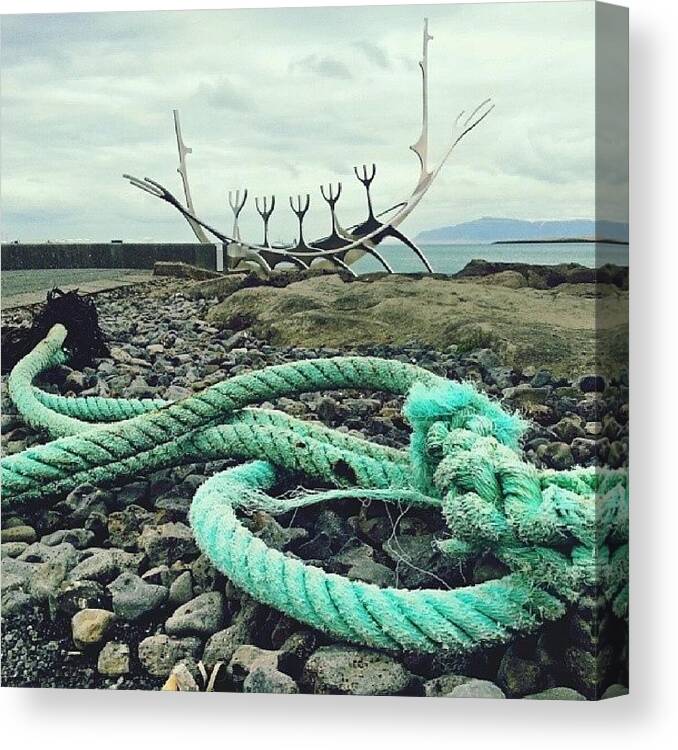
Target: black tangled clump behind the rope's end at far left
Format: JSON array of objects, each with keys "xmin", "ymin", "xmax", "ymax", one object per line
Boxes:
[{"xmin": 2, "ymin": 288, "xmax": 110, "ymax": 373}]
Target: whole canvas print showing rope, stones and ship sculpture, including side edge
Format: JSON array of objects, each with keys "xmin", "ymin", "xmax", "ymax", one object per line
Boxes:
[{"xmin": 1, "ymin": 1, "xmax": 629, "ymax": 701}]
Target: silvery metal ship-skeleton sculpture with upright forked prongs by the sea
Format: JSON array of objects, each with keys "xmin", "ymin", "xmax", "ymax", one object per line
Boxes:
[{"xmin": 123, "ymin": 19, "xmax": 494, "ymax": 276}]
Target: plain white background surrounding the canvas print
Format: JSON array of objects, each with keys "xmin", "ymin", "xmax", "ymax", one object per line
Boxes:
[{"xmin": 0, "ymin": 0, "xmax": 678, "ymax": 750}]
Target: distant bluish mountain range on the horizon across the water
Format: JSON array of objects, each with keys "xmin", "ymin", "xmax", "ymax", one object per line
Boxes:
[{"xmin": 416, "ymin": 216, "xmax": 629, "ymax": 245}]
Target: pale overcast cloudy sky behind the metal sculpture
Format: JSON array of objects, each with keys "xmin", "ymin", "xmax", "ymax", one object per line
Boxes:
[{"xmin": 0, "ymin": 2, "xmax": 623, "ymax": 241}]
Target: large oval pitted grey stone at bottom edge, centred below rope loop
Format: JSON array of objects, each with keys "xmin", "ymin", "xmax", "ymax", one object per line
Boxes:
[{"xmin": 303, "ymin": 645, "xmax": 412, "ymax": 695}]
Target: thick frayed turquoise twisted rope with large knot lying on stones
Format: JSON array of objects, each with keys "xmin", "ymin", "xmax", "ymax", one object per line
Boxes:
[{"xmin": 2, "ymin": 325, "xmax": 628, "ymax": 652}]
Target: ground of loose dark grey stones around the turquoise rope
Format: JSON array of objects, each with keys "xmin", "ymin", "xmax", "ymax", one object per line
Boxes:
[{"xmin": 2, "ymin": 280, "xmax": 628, "ymax": 700}]
